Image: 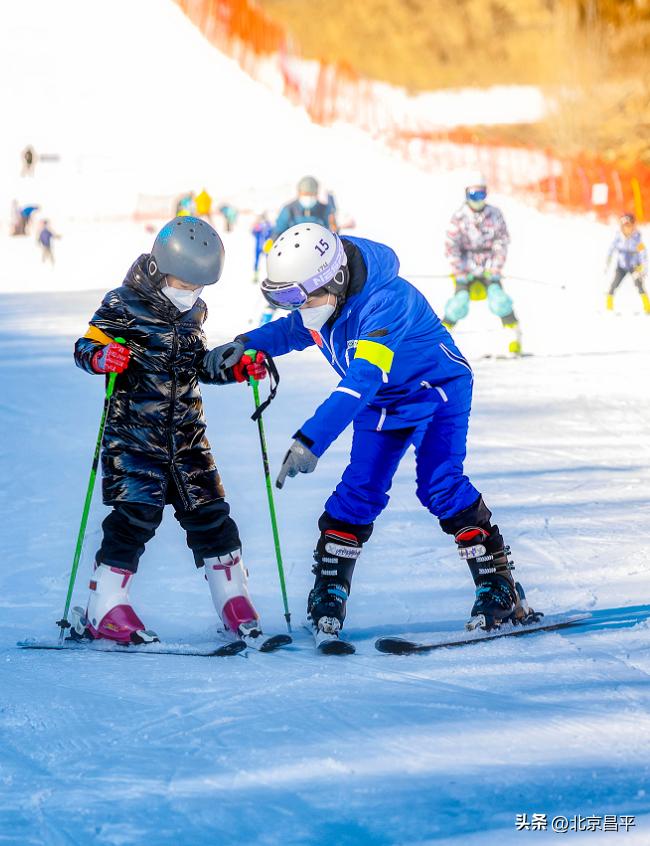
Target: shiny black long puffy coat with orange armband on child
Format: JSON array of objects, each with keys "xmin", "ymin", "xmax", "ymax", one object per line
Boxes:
[{"xmin": 74, "ymin": 255, "xmax": 224, "ymax": 509}]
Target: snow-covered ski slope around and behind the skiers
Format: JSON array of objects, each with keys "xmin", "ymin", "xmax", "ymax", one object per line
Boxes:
[{"xmin": 0, "ymin": 1, "xmax": 650, "ymax": 846}]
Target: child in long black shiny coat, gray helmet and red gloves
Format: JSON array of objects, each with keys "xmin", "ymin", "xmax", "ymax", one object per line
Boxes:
[{"xmin": 75, "ymin": 217, "xmax": 264, "ymax": 645}]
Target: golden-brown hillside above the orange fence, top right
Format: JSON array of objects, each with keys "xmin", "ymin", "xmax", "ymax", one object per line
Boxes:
[{"xmin": 259, "ymin": 0, "xmax": 650, "ymax": 162}]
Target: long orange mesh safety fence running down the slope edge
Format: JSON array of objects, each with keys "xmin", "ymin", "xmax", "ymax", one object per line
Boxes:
[{"xmin": 175, "ymin": 0, "xmax": 650, "ymax": 221}]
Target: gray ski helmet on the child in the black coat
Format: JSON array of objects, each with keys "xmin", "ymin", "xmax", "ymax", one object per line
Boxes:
[{"xmin": 147, "ymin": 215, "xmax": 225, "ymax": 285}]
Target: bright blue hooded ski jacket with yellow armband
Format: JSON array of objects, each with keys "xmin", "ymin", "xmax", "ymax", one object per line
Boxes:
[{"xmin": 239, "ymin": 237, "xmax": 472, "ymax": 456}]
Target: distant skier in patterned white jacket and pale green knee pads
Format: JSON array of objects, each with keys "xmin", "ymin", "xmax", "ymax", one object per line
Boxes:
[{"xmin": 443, "ymin": 173, "xmax": 521, "ymax": 354}]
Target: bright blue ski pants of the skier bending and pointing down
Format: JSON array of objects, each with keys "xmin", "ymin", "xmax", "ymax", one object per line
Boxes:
[{"xmin": 325, "ymin": 377, "xmax": 480, "ymax": 524}]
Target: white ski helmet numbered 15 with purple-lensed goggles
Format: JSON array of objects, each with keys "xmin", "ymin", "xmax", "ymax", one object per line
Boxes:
[{"xmin": 262, "ymin": 222, "xmax": 348, "ymax": 308}]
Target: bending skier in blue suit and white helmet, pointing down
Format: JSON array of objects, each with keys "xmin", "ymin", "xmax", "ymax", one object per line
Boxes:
[{"xmin": 205, "ymin": 223, "xmax": 528, "ymax": 642}]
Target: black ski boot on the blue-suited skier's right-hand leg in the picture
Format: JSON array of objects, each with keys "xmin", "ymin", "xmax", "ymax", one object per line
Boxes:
[{"xmin": 454, "ymin": 526, "xmax": 529, "ymax": 631}]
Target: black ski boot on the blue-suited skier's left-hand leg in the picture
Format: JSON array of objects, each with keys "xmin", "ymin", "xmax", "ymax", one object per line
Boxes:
[{"xmin": 307, "ymin": 529, "xmax": 361, "ymax": 642}]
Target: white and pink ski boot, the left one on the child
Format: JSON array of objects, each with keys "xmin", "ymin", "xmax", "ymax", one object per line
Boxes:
[{"xmin": 73, "ymin": 563, "xmax": 159, "ymax": 644}]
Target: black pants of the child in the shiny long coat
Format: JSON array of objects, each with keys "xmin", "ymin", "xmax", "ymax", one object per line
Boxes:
[{"xmin": 96, "ymin": 480, "xmax": 241, "ymax": 573}]
